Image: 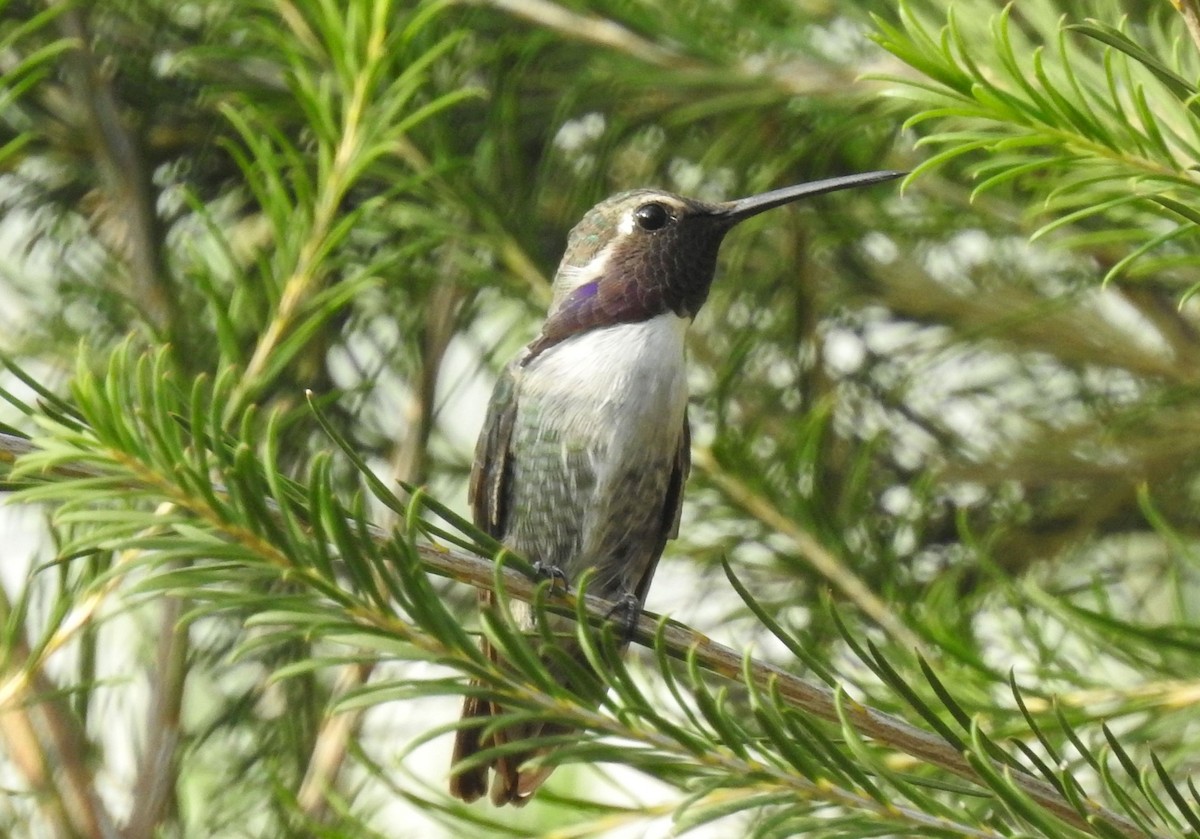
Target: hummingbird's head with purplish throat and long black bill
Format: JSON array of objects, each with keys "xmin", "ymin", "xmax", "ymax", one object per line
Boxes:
[{"xmin": 529, "ymin": 172, "xmax": 904, "ymax": 358}]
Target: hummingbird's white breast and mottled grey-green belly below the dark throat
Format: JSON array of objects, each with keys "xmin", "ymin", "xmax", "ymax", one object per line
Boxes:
[{"xmin": 505, "ymin": 313, "xmax": 689, "ymax": 598}]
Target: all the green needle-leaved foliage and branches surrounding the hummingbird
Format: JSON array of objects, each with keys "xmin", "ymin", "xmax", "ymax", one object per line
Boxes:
[{"xmin": 0, "ymin": 0, "xmax": 1200, "ymax": 838}]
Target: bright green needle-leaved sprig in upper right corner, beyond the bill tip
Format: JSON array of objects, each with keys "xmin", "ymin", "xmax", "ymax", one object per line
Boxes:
[{"xmin": 877, "ymin": 2, "xmax": 1200, "ymax": 295}]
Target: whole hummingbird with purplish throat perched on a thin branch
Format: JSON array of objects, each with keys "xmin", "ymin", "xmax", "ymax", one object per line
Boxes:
[{"xmin": 450, "ymin": 166, "xmax": 905, "ymax": 805}]
